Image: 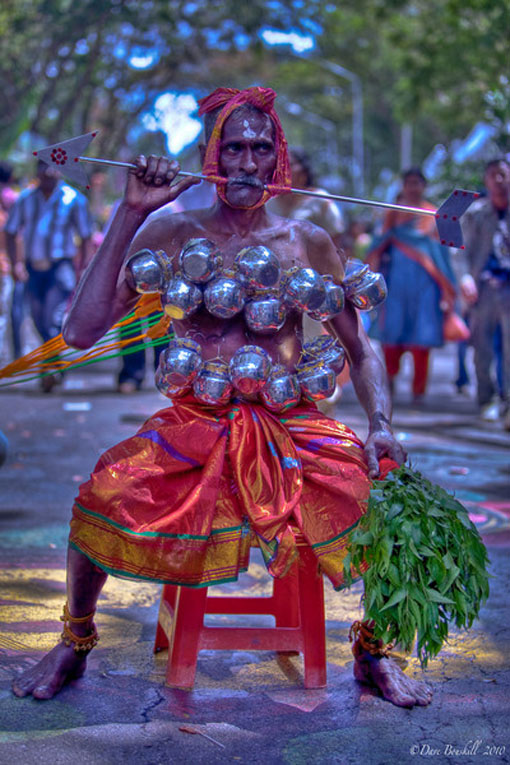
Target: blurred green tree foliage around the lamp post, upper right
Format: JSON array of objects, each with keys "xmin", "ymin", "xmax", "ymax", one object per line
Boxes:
[{"xmin": 279, "ymin": 0, "xmax": 510, "ymax": 190}]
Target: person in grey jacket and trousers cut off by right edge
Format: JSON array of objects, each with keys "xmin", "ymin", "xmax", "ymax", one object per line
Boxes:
[{"xmin": 460, "ymin": 158, "xmax": 510, "ymax": 431}]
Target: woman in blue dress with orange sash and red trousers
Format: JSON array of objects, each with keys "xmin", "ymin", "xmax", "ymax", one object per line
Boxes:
[{"xmin": 366, "ymin": 167, "xmax": 456, "ymax": 402}]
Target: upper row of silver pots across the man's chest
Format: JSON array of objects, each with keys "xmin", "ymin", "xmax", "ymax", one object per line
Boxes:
[{"xmin": 126, "ymin": 239, "xmax": 382, "ymax": 334}]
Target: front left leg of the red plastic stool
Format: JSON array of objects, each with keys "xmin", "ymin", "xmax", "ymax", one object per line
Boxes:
[{"xmin": 166, "ymin": 587, "xmax": 208, "ymax": 689}]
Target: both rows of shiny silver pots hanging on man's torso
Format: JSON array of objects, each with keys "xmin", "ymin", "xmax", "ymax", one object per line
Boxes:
[{"xmin": 126, "ymin": 239, "xmax": 385, "ymax": 411}]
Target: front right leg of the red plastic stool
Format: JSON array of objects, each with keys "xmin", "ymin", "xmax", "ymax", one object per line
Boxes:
[{"xmin": 298, "ymin": 547, "xmax": 327, "ymax": 688}]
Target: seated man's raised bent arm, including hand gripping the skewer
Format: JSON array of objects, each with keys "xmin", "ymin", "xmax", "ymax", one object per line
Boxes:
[{"xmin": 63, "ymin": 156, "xmax": 197, "ymax": 348}]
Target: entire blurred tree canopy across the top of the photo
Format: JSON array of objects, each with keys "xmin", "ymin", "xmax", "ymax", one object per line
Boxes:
[{"xmin": 0, "ymin": 0, "xmax": 510, "ymax": 191}]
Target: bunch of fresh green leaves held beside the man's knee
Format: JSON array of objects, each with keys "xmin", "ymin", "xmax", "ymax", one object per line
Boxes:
[{"xmin": 344, "ymin": 465, "xmax": 489, "ymax": 667}]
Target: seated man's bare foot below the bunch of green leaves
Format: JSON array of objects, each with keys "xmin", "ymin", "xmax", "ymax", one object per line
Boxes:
[{"xmin": 354, "ymin": 651, "xmax": 432, "ymax": 707}]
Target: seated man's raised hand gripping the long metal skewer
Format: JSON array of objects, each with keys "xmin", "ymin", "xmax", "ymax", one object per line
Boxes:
[{"xmin": 124, "ymin": 154, "xmax": 200, "ymax": 215}]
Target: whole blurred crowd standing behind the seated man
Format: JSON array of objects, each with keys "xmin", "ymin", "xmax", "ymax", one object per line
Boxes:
[{"xmin": 0, "ymin": 147, "xmax": 510, "ymax": 431}]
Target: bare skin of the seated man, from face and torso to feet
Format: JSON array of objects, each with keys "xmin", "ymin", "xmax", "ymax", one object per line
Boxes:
[{"xmin": 13, "ymin": 89, "xmax": 431, "ymax": 706}]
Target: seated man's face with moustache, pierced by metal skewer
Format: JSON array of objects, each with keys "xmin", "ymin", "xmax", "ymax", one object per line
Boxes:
[{"xmin": 219, "ymin": 109, "xmax": 276, "ymax": 208}]
